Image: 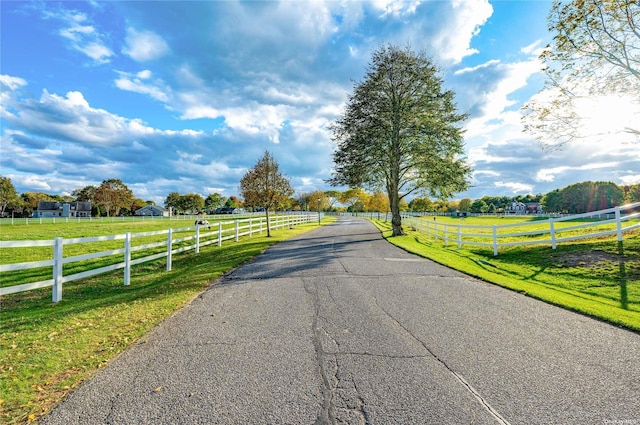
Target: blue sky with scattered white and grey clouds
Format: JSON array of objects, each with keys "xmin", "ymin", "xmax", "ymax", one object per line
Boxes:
[{"xmin": 0, "ymin": 0, "xmax": 640, "ymax": 205}]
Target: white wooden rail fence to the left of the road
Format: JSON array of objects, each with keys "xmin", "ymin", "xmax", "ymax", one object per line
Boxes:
[{"xmin": 0, "ymin": 213, "xmax": 318, "ymax": 302}]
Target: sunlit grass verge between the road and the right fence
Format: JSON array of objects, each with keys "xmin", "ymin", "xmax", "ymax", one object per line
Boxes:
[{"xmin": 373, "ymin": 220, "xmax": 640, "ymax": 331}]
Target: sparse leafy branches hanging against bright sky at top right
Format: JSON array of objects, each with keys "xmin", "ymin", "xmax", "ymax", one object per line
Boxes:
[{"xmin": 523, "ymin": 0, "xmax": 640, "ymax": 148}]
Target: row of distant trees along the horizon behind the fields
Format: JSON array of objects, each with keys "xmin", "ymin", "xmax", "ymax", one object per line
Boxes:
[{"xmin": 0, "ymin": 176, "xmax": 640, "ymax": 217}]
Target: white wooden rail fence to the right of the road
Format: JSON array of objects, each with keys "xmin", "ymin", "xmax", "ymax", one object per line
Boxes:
[{"xmin": 402, "ymin": 202, "xmax": 640, "ymax": 256}]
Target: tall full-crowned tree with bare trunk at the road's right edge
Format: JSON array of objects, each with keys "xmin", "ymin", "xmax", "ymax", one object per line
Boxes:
[{"xmin": 329, "ymin": 45, "xmax": 471, "ymax": 235}]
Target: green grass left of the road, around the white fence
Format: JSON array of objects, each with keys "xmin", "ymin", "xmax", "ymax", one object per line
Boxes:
[{"xmin": 0, "ymin": 218, "xmax": 334, "ymax": 424}]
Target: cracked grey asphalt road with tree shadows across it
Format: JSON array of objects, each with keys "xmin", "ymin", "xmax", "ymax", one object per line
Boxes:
[{"xmin": 42, "ymin": 219, "xmax": 640, "ymax": 425}]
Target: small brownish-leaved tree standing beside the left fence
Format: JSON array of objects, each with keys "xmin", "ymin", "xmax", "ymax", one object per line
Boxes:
[{"xmin": 240, "ymin": 151, "xmax": 294, "ymax": 237}]
